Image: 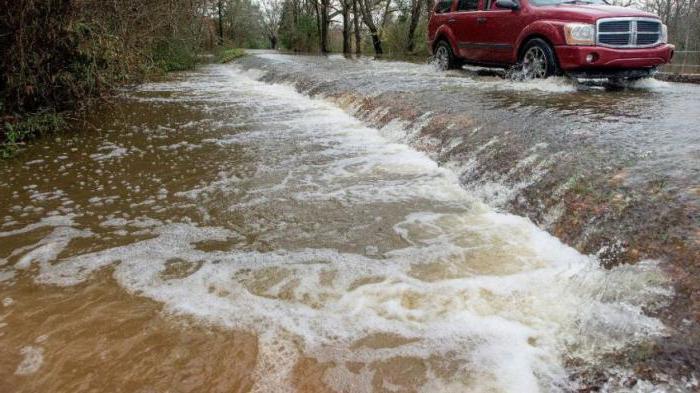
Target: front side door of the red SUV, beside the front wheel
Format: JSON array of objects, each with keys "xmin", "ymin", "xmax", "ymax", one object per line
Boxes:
[{"xmin": 474, "ymin": 0, "xmax": 524, "ymax": 64}]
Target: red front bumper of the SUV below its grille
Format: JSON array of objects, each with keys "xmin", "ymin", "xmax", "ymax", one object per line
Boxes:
[{"xmin": 555, "ymin": 44, "xmax": 674, "ymax": 71}]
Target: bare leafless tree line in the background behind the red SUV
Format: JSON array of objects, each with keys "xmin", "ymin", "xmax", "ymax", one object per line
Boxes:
[{"xmin": 242, "ymin": 0, "xmax": 700, "ymax": 56}]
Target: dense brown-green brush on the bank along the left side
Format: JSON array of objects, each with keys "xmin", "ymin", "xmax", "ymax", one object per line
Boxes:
[{"xmin": 0, "ymin": 0, "xmax": 215, "ymax": 155}]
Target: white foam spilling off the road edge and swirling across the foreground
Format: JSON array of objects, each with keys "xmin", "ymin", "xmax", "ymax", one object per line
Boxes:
[{"xmin": 14, "ymin": 66, "xmax": 670, "ymax": 392}]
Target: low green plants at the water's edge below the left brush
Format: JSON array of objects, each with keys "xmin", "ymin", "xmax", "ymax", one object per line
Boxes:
[{"xmin": 0, "ymin": 111, "xmax": 66, "ymax": 158}]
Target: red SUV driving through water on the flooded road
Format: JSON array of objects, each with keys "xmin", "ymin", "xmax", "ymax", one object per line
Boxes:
[{"xmin": 428, "ymin": 0, "xmax": 674, "ymax": 78}]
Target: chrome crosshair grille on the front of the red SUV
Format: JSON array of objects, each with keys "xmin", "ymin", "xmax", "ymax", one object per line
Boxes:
[{"xmin": 596, "ymin": 18, "xmax": 661, "ymax": 48}]
